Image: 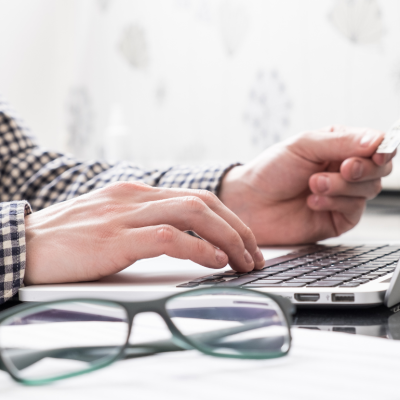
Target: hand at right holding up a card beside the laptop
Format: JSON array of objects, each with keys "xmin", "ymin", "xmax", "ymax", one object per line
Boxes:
[{"xmin": 219, "ymin": 127, "xmax": 395, "ymax": 244}]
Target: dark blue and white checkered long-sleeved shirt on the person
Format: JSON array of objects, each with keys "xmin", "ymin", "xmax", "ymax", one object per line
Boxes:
[{"xmin": 0, "ymin": 98, "xmax": 236, "ymax": 304}]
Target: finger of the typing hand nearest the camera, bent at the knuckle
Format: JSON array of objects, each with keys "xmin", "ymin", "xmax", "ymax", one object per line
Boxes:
[{"xmin": 126, "ymin": 225, "xmax": 228, "ymax": 268}]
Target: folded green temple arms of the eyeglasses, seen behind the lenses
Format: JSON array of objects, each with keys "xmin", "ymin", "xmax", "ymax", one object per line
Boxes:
[{"xmin": 0, "ymin": 321, "xmax": 284, "ymax": 370}]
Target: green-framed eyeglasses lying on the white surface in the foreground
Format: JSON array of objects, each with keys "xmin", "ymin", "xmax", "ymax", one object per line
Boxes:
[{"xmin": 0, "ymin": 288, "xmax": 294, "ymax": 385}]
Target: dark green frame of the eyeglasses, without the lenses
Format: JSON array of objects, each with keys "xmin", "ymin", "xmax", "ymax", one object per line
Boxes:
[{"xmin": 0, "ymin": 287, "xmax": 296, "ymax": 386}]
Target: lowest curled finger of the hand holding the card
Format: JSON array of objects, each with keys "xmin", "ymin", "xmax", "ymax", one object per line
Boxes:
[{"xmin": 307, "ymin": 194, "xmax": 366, "ymax": 235}]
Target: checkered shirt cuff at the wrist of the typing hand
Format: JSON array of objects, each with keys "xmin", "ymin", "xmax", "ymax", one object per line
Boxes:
[{"xmin": 0, "ymin": 201, "xmax": 32, "ymax": 304}]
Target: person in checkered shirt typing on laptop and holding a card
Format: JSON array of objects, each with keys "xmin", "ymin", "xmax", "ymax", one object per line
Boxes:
[{"xmin": 0, "ymin": 100, "xmax": 394, "ymax": 303}]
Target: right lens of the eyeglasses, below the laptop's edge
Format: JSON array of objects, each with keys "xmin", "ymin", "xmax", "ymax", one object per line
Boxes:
[{"xmin": 166, "ymin": 290, "xmax": 290, "ymax": 358}]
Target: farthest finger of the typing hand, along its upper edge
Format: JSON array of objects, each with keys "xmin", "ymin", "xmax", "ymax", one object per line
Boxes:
[{"xmin": 135, "ymin": 188, "xmax": 265, "ymax": 269}]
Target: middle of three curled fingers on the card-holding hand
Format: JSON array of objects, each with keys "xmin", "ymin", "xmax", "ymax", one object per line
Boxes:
[{"xmin": 309, "ymin": 172, "xmax": 382, "ymax": 200}]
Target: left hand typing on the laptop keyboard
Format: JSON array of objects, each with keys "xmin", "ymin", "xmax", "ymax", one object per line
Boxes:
[{"xmin": 24, "ymin": 182, "xmax": 264, "ymax": 285}]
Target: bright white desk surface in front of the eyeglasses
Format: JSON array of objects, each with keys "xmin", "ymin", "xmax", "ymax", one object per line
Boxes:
[{"xmin": 0, "ymin": 329, "xmax": 400, "ymax": 400}]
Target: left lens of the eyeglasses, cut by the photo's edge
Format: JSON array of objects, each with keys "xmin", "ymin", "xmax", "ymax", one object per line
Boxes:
[{"xmin": 0, "ymin": 301, "xmax": 129, "ymax": 383}]
